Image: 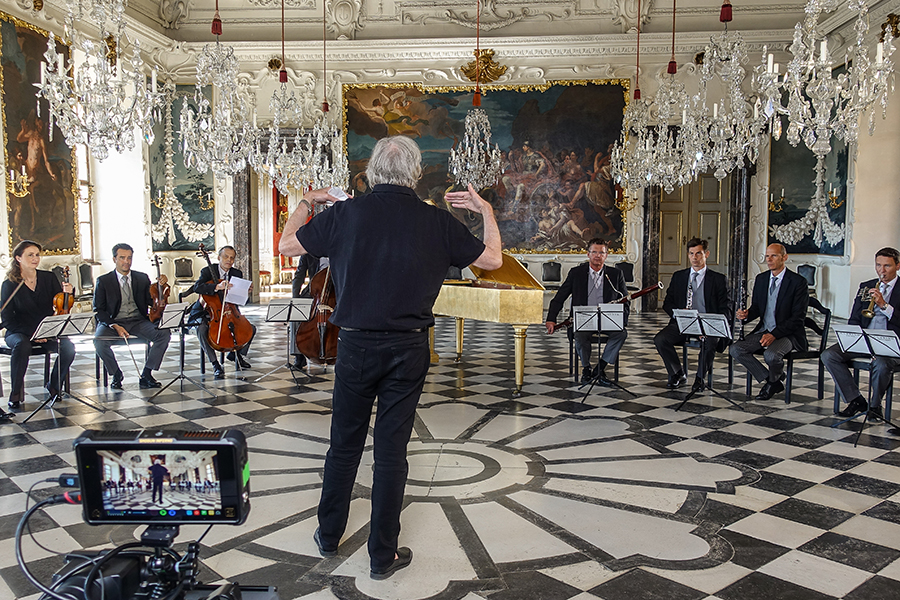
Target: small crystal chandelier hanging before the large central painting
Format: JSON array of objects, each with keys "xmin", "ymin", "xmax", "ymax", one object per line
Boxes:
[{"xmin": 449, "ymin": 0, "xmax": 503, "ymax": 190}]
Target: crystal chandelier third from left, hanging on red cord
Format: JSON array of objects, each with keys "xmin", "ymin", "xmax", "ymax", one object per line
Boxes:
[{"xmin": 248, "ymin": 0, "xmax": 309, "ymax": 195}]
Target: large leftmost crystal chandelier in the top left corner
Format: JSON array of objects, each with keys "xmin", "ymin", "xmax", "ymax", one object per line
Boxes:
[{"xmin": 36, "ymin": 0, "xmax": 162, "ymax": 160}]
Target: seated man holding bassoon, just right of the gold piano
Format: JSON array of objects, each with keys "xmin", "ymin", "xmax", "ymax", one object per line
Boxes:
[{"xmin": 546, "ymin": 238, "xmax": 630, "ymax": 384}]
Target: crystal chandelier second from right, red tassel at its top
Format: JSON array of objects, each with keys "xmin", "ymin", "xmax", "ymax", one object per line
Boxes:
[{"xmin": 688, "ymin": 0, "xmax": 767, "ymax": 181}]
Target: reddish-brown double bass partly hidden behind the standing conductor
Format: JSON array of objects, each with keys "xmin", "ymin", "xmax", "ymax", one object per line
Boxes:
[{"xmin": 296, "ymin": 266, "xmax": 341, "ymax": 365}]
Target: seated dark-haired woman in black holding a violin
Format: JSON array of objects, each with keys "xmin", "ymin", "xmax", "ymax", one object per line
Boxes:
[{"xmin": 0, "ymin": 240, "xmax": 75, "ymax": 418}]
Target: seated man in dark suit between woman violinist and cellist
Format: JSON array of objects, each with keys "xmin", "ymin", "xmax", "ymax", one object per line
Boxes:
[{"xmin": 94, "ymin": 244, "xmax": 169, "ymax": 390}]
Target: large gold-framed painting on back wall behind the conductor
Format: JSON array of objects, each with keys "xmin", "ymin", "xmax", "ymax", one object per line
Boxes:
[{"xmin": 343, "ymin": 79, "xmax": 629, "ymax": 253}]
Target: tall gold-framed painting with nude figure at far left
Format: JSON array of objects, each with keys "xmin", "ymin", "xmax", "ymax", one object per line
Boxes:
[{"xmin": 0, "ymin": 13, "xmax": 79, "ymax": 254}]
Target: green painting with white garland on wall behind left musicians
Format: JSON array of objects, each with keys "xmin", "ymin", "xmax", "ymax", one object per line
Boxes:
[{"xmin": 147, "ymin": 85, "xmax": 215, "ymax": 252}]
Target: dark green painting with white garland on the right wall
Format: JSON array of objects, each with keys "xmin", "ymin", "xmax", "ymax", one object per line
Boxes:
[{"xmin": 768, "ymin": 130, "xmax": 850, "ymax": 256}]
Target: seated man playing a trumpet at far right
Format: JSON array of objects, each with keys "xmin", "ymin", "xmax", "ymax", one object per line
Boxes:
[{"xmin": 822, "ymin": 248, "xmax": 900, "ymax": 420}]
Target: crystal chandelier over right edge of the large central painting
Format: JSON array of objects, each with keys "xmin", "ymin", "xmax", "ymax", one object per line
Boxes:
[{"xmin": 610, "ymin": 0, "xmax": 654, "ymax": 193}]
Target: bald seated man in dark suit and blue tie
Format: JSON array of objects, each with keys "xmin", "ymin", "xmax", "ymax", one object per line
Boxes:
[{"xmin": 731, "ymin": 244, "xmax": 809, "ymax": 400}]
